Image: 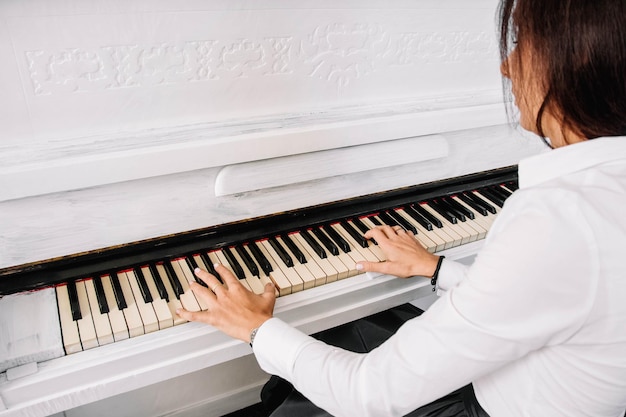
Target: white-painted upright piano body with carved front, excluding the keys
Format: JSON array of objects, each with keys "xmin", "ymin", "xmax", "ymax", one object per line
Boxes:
[{"xmin": 0, "ymin": 0, "xmax": 543, "ymax": 417}]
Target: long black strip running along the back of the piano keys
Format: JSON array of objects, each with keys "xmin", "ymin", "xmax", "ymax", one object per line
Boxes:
[{"xmin": 0, "ymin": 167, "xmax": 517, "ymax": 296}]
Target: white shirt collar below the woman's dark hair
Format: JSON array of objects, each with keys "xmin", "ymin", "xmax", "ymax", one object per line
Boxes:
[{"xmin": 518, "ymin": 136, "xmax": 626, "ymax": 188}]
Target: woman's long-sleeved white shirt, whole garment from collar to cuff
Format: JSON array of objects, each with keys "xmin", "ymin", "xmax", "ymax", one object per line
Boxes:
[{"xmin": 254, "ymin": 137, "xmax": 626, "ymax": 417}]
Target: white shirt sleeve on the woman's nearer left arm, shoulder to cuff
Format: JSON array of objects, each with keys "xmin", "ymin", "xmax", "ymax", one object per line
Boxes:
[{"xmin": 254, "ymin": 191, "xmax": 596, "ymax": 416}]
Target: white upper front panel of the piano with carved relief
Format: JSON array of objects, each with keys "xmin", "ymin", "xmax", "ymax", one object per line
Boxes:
[{"xmin": 0, "ymin": 0, "xmax": 499, "ymax": 143}]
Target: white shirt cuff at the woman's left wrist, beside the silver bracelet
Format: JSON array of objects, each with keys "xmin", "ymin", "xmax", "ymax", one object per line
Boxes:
[{"xmin": 252, "ymin": 317, "xmax": 316, "ymax": 380}]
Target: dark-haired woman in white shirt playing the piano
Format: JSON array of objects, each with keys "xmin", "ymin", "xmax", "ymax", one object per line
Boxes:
[{"xmin": 179, "ymin": 0, "xmax": 626, "ymax": 417}]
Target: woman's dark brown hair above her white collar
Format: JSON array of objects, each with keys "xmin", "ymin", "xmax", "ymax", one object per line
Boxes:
[{"xmin": 498, "ymin": 0, "xmax": 626, "ymax": 143}]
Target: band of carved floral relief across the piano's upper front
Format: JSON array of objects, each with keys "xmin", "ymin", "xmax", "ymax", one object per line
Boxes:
[{"xmin": 24, "ymin": 23, "xmax": 497, "ymax": 96}]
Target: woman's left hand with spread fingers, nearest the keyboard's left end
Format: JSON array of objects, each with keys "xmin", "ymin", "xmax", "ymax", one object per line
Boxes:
[{"xmin": 176, "ymin": 265, "xmax": 276, "ymax": 343}]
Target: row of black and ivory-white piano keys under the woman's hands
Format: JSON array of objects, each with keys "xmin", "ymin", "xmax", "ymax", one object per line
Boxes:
[{"xmin": 56, "ymin": 180, "xmax": 517, "ymax": 354}]
